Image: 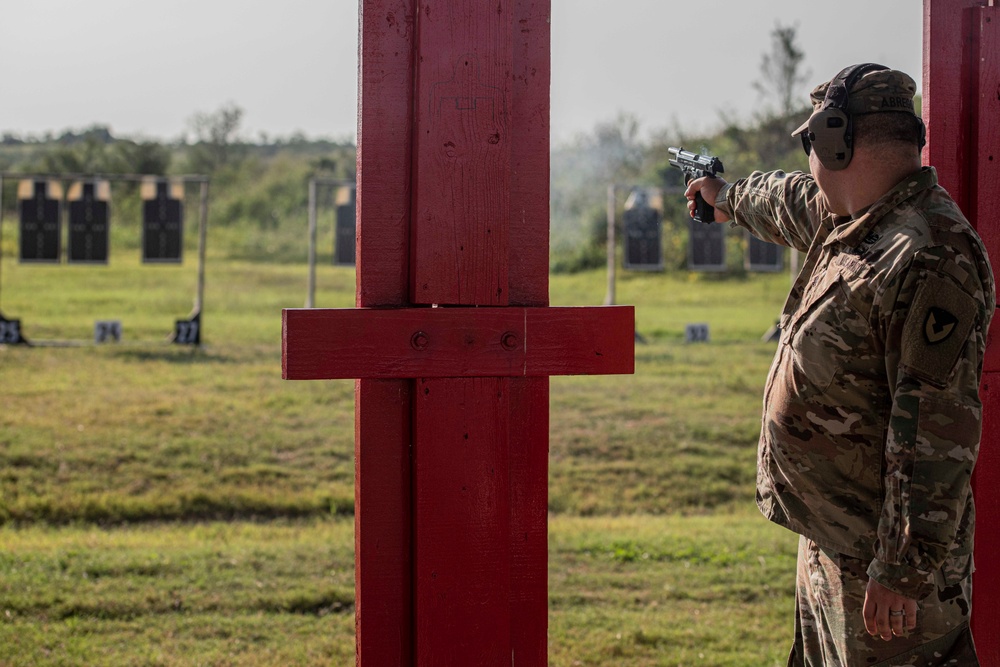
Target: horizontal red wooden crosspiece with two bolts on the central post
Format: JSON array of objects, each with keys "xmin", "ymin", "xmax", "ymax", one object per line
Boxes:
[{"xmin": 281, "ymin": 306, "xmax": 635, "ymax": 380}]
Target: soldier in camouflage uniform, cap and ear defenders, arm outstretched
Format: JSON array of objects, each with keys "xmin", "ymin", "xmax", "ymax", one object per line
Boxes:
[{"xmin": 686, "ymin": 64, "xmax": 996, "ymax": 667}]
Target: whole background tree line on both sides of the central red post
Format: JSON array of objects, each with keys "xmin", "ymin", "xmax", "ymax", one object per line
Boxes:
[{"xmin": 0, "ymin": 24, "xmax": 809, "ymax": 271}]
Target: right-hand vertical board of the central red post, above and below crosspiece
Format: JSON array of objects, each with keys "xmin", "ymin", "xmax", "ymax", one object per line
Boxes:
[{"xmin": 509, "ymin": 0, "xmax": 551, "ymax": 667}]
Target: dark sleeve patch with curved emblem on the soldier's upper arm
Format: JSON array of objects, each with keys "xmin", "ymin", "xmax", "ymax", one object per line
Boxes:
[{"xmin": 900, "ymin": 277, "xmax": 979, "ymax": 386}]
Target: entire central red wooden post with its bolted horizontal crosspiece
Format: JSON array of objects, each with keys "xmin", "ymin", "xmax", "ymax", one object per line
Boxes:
[{"xmin": 282, "ymin": 0, "xmax": 635, "ymax": 667}]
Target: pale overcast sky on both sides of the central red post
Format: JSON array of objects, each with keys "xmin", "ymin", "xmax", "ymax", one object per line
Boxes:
[{"xmin": 0, "ymin": 0, "xmax": 922, "ymax": 142}]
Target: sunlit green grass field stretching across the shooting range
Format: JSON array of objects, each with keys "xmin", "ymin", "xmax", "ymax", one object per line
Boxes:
[{"xmin": 0, "ymin": 250, "xmax": 795, "ymax": 667}]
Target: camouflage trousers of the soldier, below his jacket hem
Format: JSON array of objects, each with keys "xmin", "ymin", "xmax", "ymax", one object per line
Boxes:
[{"xmin": 788, "ymin": 537, "xmax": 979, "ymax": 667}]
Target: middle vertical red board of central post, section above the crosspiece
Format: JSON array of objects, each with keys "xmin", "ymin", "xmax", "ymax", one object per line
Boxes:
[{"xmin": 411, "ymin": 0, "xmax": 512, "ymax": 305}]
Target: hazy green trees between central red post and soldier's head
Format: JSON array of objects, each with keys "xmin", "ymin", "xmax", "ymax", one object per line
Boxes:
[{"xmin": 551, "ymin": 23, "xmax": 810, "ymax": 272}]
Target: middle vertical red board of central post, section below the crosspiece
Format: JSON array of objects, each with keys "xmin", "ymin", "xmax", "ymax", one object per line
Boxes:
[{"xmin": 414, "ymin": 378, "xmax": 511, "ymax": 667}]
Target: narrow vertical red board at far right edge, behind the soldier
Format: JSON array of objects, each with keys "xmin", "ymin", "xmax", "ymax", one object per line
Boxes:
[{"xmin": 967, "ymin": 7, "xmax": 1000, "ymax": 665}]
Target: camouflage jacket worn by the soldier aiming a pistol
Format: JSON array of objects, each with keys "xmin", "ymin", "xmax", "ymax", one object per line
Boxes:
[{"xmin": 716, "ymin": 168, "xmax": 996, "ymax": 598}]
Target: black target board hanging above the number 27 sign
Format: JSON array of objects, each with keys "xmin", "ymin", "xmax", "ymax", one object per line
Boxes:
[{"xmin": 142, "ymin": 179, "xmax": 184, "ymax": 264}]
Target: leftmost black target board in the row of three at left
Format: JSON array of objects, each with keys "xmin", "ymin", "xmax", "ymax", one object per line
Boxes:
[{"xmin": 17, "ymin": 180, "xmax": 62, "ymax": 263}]
